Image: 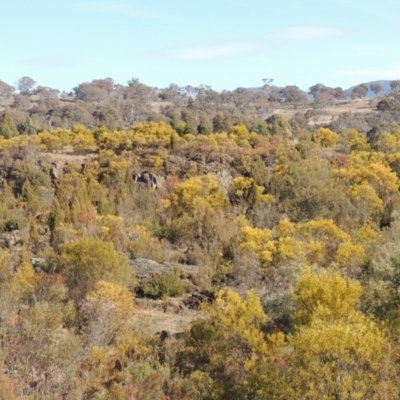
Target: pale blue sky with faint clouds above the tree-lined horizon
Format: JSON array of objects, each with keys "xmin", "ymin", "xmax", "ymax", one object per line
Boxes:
[{"xmin": 0, "ymin": 0, "xmax": 400, "ymax": 91}]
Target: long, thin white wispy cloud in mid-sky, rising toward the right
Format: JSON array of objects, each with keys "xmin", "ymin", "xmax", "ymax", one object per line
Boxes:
[{"xmin": 156, "ymin": 26, "xmax": 347, "ymax": 61}]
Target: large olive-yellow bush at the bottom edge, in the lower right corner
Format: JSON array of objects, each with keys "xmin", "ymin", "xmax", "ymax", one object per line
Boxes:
[{"xmin": 289, "ymin": 306, "xmax": 397, "ymax": 399}]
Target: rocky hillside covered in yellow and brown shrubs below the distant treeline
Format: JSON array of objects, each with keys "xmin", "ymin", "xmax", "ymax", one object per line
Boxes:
[{"xmin": 0, "ymin": 111, "xmax": 400, "ymax": 400}]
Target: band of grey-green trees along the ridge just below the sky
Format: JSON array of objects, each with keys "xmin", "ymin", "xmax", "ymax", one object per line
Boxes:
[{"xmin": 0, "ymin": 76, "xmax": 399, "ymax": 139}]
